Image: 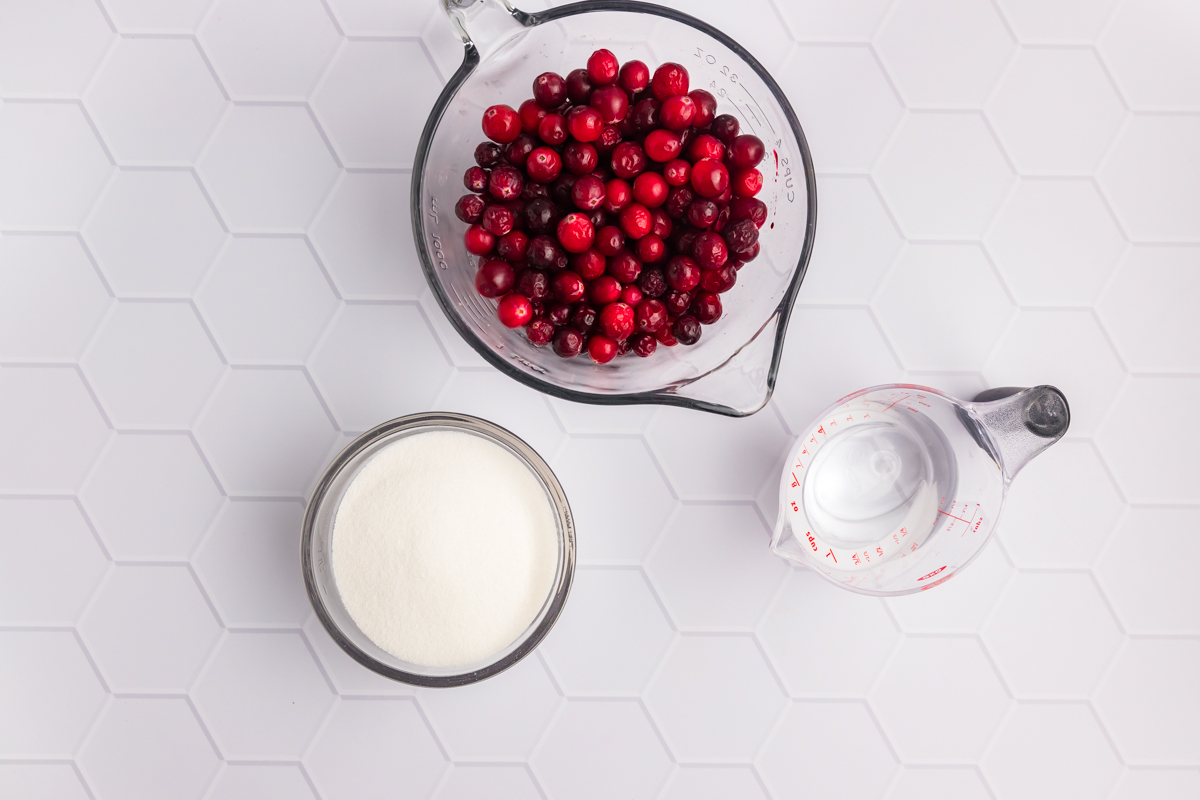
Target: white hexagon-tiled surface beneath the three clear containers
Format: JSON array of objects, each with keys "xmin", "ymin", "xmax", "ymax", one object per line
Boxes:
[{"xmin": 0, "ymin": 0, "xmax": 1200, "ymax": 800}]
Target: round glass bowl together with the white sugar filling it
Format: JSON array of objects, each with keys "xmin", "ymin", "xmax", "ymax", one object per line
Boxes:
[{"xmin": 300, "ymin": 413, "xmax": 575, "ymax": 687}]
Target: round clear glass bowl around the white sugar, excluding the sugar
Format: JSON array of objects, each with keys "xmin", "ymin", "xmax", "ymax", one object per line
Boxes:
[{"xmin": 300, "ymin": 413, "xmax": 575, "ymax": 687}]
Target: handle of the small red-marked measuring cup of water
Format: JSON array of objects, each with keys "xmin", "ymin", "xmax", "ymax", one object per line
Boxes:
[{"xmin": 964, "ymin": 386, "xmax": 1070, "ymax": 481}]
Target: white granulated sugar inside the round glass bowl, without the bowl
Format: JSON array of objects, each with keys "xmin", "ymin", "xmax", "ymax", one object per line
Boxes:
[{"xmin": 332, "ymin": 431, "xmax": 558, "ymax": 667}]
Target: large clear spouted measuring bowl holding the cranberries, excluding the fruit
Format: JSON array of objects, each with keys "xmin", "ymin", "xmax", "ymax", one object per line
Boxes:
[{"xmin": 412, "ymin": 0, "xmax": 816, "ymax": 416}]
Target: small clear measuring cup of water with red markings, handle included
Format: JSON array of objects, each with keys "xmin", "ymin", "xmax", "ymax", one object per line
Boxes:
[{"xmin": 770, "ymin": 384, "xmax": 1070, "ymax": 595}]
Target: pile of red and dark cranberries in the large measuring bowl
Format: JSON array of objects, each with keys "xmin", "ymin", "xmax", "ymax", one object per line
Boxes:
[{"xmin": 455, "ymin": 50, "xmax": 767, "ymax": 363}]
